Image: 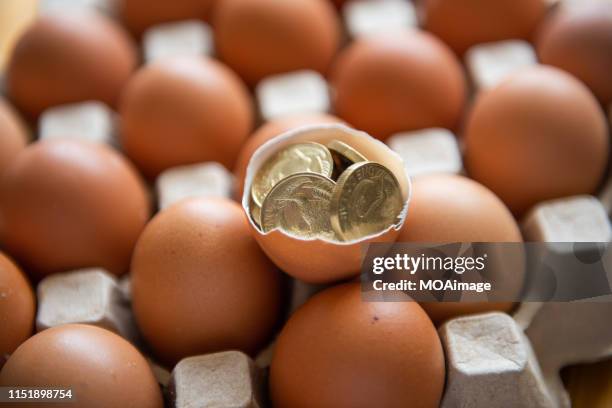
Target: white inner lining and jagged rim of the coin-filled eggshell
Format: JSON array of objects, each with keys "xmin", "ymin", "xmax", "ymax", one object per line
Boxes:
[{"xmin": 242, "ymin": 124, "xmax": 412, "ymax": 245}]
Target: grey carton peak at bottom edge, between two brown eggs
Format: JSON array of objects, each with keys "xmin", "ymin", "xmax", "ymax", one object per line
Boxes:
[{"xmin": 168, "ymin": 351, "xmax": 265, "ymax": 408}]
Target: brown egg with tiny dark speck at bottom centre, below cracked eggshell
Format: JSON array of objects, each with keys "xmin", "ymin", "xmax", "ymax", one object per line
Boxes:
[{"xmin": 270, "ymin": 283, "xmax": 445, "ymax": 408}]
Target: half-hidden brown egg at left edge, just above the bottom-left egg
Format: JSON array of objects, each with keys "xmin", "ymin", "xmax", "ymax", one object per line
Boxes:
[{"xmin": 0, "ymin": 252, "xmax": 36, "ymax": 367}]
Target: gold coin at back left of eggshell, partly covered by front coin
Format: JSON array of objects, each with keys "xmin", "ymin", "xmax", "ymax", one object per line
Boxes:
[{"xmin": 251, "ymin": 142, "xmax": 334, "ymax": 206}]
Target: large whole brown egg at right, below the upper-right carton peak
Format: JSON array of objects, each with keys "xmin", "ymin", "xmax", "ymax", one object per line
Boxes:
[{"xmin": 465, "ymin": 66, "xmax": 609, "ymax": 215}]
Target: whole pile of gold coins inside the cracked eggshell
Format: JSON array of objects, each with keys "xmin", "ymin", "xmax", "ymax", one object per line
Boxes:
[{"xmin": 250, "ymin": 140, "xmax": 404, "ymax": 241}]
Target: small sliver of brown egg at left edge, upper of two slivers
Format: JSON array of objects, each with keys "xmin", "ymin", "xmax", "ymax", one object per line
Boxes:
[{"xmin": 0, "ymin": 98, "xmax": 28, "ymax": 176}]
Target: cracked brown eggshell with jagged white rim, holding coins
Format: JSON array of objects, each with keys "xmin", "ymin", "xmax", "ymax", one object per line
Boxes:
[{"xmin": 242, "ymin": 124, "xmax": 411, "ymax": 283}]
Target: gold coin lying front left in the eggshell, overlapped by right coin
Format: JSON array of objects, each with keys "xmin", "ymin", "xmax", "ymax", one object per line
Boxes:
[{"xmin": 261, "ymin": 173, "xmax": 336, "ymax": 239}]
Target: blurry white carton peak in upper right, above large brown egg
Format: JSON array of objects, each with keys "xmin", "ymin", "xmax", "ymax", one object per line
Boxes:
[{"xmin": 465, "ymin": 40, "xmax": 538, "ymax": 91}]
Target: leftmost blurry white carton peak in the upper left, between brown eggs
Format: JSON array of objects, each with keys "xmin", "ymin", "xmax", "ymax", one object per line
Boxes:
[{"xmin": 38, "ymin": 101, "xmax": 119, "ymax": 146}]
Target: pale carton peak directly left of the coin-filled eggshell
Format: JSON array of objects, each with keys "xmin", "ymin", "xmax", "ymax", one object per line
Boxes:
[{"xmin": 155, "ymin": 162, "xmax": 234, "ymax": 210}]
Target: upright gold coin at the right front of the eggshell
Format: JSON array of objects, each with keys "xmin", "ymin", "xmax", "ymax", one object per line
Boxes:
[{"xmin": 330, "ymin": 162, "xmax": 404, "ymax": 240}]
